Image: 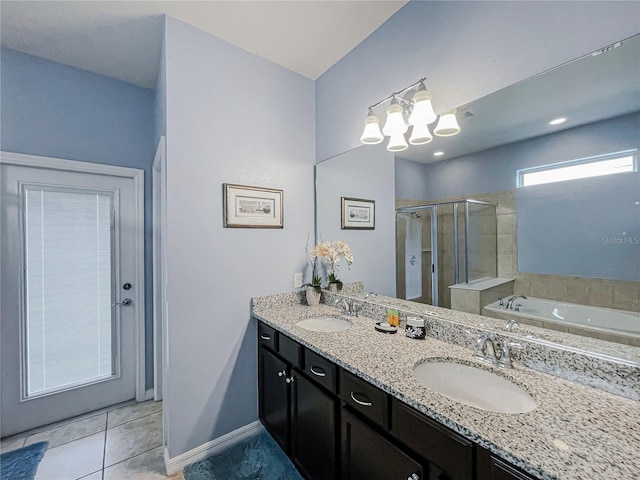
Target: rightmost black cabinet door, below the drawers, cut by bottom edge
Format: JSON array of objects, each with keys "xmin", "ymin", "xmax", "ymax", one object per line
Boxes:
[{"xmin": 340, "ymin": 408, "xmax": 424, "ymax": 480}]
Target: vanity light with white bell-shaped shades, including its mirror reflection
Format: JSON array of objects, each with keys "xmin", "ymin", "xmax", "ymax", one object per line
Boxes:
[{"xmin": 360, "ymin": 78, "xmax": 460, "ymax": 152}]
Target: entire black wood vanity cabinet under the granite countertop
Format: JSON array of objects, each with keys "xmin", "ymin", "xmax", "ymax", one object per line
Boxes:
[{"xmin": 258, "ymin": 322, "xmax": 535, "ymax": 480}]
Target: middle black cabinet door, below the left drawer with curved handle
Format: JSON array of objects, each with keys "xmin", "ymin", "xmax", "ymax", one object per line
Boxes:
[{"xmin": 291, "ymin": 370, "xmax": 337, "ymax": 480}]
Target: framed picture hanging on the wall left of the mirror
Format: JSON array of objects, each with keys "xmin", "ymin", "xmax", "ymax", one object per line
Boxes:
[{"xmin": 222, "ymin": 183, "xmax": 284, "ymax": 228}]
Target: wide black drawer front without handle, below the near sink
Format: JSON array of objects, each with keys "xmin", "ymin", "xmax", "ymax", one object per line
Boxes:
[{"xmin": 390, "ymin": 399, "xmax": 473, "ymax": 480}]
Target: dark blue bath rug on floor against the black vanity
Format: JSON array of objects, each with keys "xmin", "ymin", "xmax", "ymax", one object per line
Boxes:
[{"xmin": 184, "ymin": 432, "xmax": 302, "ymax": 480}]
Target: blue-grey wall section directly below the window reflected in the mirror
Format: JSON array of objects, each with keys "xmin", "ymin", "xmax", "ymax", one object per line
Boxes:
[{"xmin": 516, "ymin": 172, "xmax": 640, "ymax": 282}]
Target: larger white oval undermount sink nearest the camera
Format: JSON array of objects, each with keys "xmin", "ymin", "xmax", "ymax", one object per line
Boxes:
[{"xmin": 413, "ymin": 361, "xmax": 537, "ymax": 413}]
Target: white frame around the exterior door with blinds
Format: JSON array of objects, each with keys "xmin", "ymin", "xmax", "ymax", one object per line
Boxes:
[{"xmin": 0, "ymin": 151, "xmax": 147, "ymax": 402}]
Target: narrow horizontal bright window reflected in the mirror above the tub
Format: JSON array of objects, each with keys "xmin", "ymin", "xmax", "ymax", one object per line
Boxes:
[{"xmin": 516, "ymin": 149, "xmax": 638, "ymax": 188}]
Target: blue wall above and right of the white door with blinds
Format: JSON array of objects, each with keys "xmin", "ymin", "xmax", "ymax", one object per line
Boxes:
[{"xmin": 0, "ymin": 48, "xmax": 155, "ymax": 388}]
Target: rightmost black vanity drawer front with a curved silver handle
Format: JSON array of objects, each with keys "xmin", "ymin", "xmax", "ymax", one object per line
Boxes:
[{"xmin": 340, "ymin": 369, "xmax": 389, "ymax": 430}]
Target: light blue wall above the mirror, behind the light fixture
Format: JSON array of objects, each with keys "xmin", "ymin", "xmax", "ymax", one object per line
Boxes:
[{"xmin": 316, "ymin": 1, "xmax": 640, "ymax": 162}]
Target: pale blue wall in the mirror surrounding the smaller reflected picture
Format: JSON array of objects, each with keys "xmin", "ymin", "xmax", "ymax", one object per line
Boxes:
[{"xmin": 316, "ymin": 145, "xmax": 396, "ymax": 297}]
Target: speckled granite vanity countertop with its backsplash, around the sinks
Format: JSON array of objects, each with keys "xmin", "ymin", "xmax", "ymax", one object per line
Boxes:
[{"xmin": 253, "ymin": 292, "xmax": 640, "ymax": 479}]
